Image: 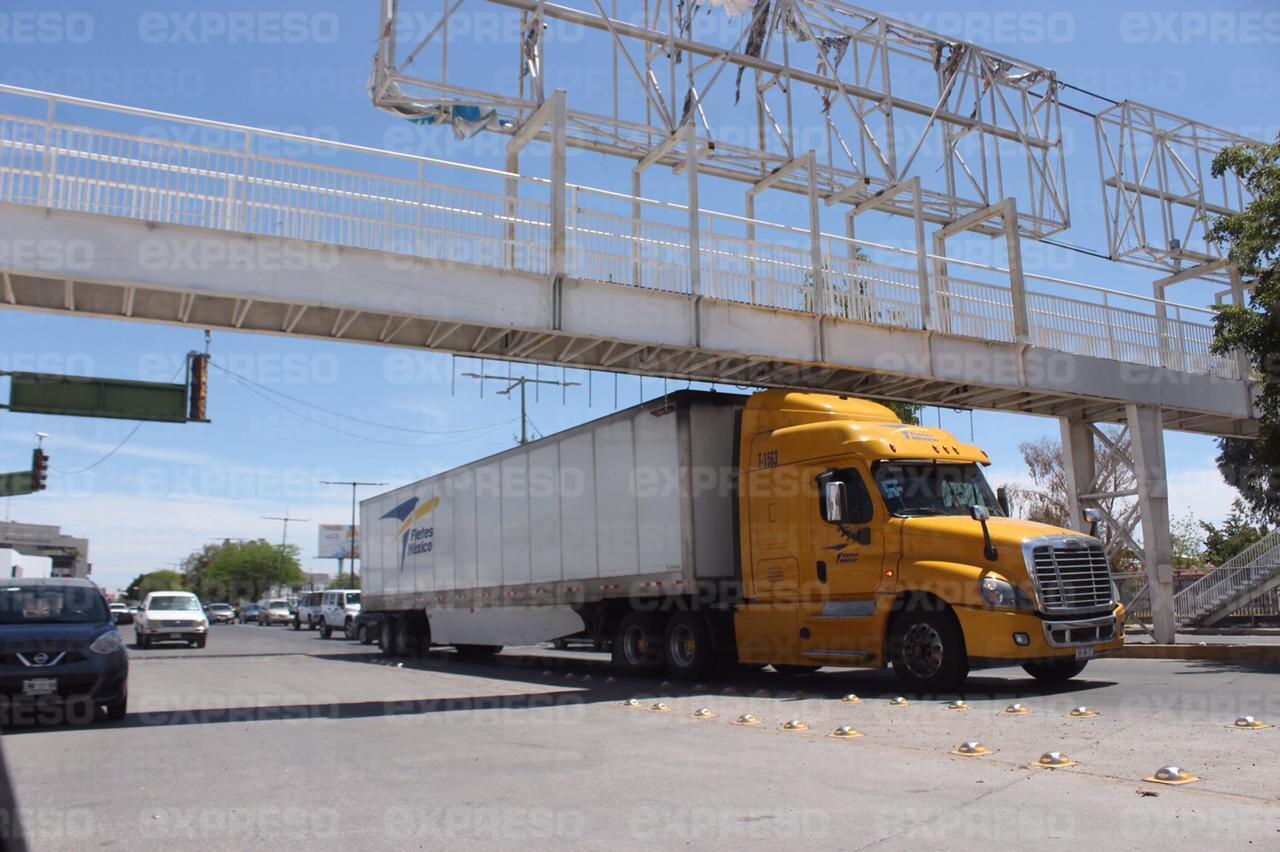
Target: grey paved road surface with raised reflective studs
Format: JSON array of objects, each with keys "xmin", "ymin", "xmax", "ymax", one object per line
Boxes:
[{"xmin": 0, "ymin": 624, "xmax": 1280, "ymax": 851}]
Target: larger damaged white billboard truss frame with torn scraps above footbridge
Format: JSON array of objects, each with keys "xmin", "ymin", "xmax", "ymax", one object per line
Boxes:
[{"xmin": 371, "ymin": 0, "xmax": 1070, "ymax": 238}]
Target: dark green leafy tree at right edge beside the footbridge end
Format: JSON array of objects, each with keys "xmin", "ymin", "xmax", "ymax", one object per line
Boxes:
[{"xmin": 1208, "ymin": 137, "xmax": 1280, "ymax": 523}]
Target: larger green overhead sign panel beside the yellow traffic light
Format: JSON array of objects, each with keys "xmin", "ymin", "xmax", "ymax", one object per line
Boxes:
[{"xmin": 8, "ymin": 372, "xmax": 187, "ymax": 423}]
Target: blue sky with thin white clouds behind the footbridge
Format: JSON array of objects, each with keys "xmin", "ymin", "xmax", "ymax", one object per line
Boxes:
[{"xmin": 0, "ymin": 0, "xmax": 1280, "ymax": 588}]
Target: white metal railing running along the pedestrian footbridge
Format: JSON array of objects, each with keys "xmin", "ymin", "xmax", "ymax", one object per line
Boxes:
[{"xmin": 0, "ymin": 86, "xmax": 1240, "ymax": 379}]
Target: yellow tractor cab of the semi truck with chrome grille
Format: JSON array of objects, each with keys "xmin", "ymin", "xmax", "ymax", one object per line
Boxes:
[{"xmin": 735, "ymin": 391, "xmax": 1124, "ymax": 690}]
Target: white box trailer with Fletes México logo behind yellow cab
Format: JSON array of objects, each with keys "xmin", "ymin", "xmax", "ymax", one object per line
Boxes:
[{"xmin": 361, "ymin": 391, "xmax": 748, "ymax": 654}]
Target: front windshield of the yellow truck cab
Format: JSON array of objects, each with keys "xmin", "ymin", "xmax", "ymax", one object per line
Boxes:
[{"xmin": 874, "ymin": 462, "xmax": 1004, "ymax": 517}]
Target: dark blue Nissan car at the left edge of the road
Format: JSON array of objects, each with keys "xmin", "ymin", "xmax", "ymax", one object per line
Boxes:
[{"xmin": 0, "ymin": 577, "xmax": 129, "ymax": 724}]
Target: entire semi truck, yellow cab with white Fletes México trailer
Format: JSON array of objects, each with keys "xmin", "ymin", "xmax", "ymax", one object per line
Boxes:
[{"xmin": 361, "ymin": 390, "xmax": 1124, "ymax": 691}]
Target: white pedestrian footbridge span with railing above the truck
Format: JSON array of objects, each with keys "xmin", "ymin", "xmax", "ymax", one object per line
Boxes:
[{"xmin": 0, "ymin": 87, "xmax": 1256, "ymax": 435}]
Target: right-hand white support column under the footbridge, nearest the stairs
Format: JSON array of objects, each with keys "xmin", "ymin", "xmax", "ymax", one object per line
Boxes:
[{"xmin": 1125, "ymin": 403, "xmax": 1175, "ymax": 642}]
